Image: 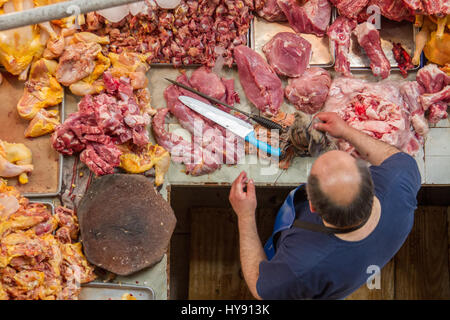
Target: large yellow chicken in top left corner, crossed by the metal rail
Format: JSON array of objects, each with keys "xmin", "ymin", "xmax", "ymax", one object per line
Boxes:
[{"xmin": 0, "ymin": 0, "xmax": 44, "ymax": 76}]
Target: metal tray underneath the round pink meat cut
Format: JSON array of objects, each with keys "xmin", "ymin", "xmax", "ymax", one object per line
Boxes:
[{"xmin": 253, "ymin": 10, "xmax": 336, "ymax": 68}]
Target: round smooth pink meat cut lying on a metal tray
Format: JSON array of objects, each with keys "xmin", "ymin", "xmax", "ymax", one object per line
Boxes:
[{"xmin": 263, "ymin": 32, "xmax": 311, "ymax": 78}]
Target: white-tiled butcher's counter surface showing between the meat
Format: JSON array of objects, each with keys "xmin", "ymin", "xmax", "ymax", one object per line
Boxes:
[{"xmin": 56, "ymin": 67, "xmax": 450, "ymax": 300}]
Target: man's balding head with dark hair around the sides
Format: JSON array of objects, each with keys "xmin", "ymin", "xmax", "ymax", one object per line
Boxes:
[{"xmin": 307, "ymin": 151, "xmax": 374, "ymax": 228}]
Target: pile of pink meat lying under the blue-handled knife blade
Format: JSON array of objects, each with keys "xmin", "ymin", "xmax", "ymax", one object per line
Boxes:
[{"xmin": 152, "ymin": 67, "xmax": 244, "ymax": 176}]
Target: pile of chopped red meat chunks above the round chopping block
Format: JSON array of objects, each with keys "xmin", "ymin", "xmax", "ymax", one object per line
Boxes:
[{"xmin": 52, "ymin": 72, "xmax": 150, "ymax": 175}]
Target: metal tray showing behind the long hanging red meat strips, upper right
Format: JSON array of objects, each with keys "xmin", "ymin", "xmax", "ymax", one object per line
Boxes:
[{"xmin": 344, "ymin": 17, "xmax": 420, "ymax": 71}]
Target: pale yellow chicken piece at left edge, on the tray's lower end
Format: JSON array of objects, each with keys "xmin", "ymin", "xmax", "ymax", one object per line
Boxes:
[{"xmin": 0, "ymin": 140, "xmax": 34, "ymax": 184}]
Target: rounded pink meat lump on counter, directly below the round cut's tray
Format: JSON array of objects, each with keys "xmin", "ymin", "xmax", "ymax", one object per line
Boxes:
[{"xmin": 285, "ymin": 67, "xmax": 331, "ymax": 114}]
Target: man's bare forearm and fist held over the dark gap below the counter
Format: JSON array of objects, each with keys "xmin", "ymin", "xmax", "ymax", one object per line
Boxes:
[{"xmin": 229, "ymin": 171, "xmax": 267, "ymax": 299}]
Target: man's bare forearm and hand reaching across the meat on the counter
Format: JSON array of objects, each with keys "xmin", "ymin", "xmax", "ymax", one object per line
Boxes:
[{"xmin": 314, "ymin": 112, "xmax": 400, "ymax": 166}]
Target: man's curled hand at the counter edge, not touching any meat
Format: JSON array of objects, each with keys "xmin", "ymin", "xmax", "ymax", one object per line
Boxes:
[{"xmin": 229, "ymin": 171, "xmax": 257, "ymax": 219}]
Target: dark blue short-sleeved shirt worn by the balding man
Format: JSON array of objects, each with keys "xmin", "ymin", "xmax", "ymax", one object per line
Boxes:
[{"xmin": 256, "ymin": 153, "xmax": 421, "ymax": 299}]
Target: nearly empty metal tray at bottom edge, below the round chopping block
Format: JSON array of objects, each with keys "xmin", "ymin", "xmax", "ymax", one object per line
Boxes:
[{"xmin": 78, "ymin": 282, "xmax": 155, "ymax": 300}]
